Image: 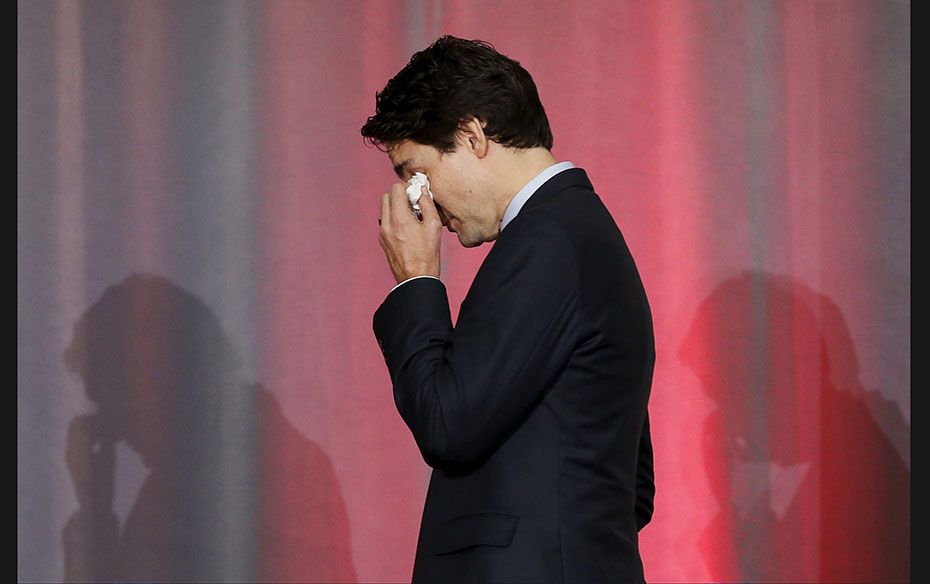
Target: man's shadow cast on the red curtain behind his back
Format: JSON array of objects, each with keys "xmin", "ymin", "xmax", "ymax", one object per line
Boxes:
[{"xmin": 678, "ymin": 271, "xmax": 910, "ymax": 583}]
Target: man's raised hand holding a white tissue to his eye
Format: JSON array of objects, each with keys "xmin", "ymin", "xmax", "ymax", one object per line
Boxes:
[{"xmin": 378, "ymin": 183, "xmax": 442, "ymax": 284}]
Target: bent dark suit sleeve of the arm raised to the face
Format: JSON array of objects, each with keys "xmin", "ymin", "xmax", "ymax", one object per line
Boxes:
[{"xmin": 373, "ymin": 214, "xmax": 578, "ymax": 468}]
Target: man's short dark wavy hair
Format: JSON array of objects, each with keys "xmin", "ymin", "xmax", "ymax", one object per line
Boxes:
[{"xmin": 361, "ymin": 35, "xmax": 552, "ymax": 153}]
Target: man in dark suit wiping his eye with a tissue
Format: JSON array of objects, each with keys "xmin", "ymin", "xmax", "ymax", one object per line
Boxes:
[{"xmin": 362, "ymin": 36, "xmax": 655, "ymax": 584}]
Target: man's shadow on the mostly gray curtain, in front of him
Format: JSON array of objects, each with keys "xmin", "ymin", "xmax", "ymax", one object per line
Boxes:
[{"xmin": 63, "ymin": 274, "xmax": 356, "ymax": 582}]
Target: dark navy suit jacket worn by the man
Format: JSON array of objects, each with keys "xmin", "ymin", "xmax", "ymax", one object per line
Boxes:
[{"xmin": 373, "ymin": 167, "xmax": 655, "ymax": 584}]
